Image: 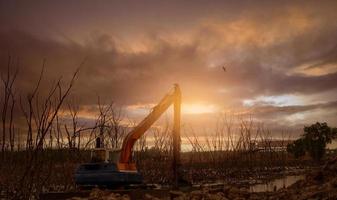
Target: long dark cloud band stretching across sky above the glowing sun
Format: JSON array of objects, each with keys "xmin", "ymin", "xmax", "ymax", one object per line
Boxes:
[{"xmin": 0, "ymin": 22, "xmax": 337, "ymax": 107}]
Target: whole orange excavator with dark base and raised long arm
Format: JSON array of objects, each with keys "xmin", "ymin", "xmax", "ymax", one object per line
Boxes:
[{"xmin": 75, "ymin": 84, "xmax": 181, "ymax": 187}]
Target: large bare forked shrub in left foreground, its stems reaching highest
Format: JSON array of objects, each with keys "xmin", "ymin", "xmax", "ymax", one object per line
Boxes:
[{"xmin": 16, "ymin": 61, "xmax": 83, "ymax": 198}]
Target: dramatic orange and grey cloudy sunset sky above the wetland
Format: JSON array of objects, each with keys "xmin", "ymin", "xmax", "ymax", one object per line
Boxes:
[{"xmin": 0, "ymin": 0, "xmax": 337, "ymax": 138}]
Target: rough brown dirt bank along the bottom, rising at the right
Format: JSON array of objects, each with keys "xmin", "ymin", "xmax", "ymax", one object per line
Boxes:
[{"xmin": 51, "ymin": 158, "xmax": 337, "ymax": 200}]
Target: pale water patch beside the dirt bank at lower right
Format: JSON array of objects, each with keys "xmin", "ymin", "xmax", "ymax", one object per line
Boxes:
[{"xmin": 249, "ymin": 175, "xmax": 305, "ymax": 192}]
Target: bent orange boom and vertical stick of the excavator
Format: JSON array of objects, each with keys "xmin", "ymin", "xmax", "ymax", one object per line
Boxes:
[{"xmin": 117, "ymin": 84, "xmax": 181, "ymax": 173}]
